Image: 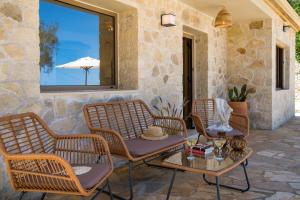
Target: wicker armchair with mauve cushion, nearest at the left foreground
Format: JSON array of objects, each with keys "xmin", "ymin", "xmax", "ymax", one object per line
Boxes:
[{"xmin": 0, "ymin": 113, "xmax": 113, "ymax": 199}]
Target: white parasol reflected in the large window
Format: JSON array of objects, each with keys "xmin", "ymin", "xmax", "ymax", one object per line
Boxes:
[{"xmin": 56, "ymin": 57, "xmax": 100, "ymax": 85}]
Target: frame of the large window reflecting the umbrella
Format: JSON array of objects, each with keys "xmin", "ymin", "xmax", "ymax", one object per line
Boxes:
[{"xmin": 39, "ymin": 0, "xmax": 118, "ymax": 92}]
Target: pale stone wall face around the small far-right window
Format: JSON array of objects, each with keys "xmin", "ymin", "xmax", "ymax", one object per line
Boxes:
[{"xmin": 272, "ymin": 17, "xmax": 296, "ymax": 128}]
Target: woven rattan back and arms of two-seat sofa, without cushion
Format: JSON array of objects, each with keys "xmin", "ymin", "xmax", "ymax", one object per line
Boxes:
[{"xmin": 84, "ymin": 100, "xmax": 187, "ymax": 160}]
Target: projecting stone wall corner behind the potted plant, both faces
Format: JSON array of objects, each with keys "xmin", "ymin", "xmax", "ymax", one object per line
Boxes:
[{"xmin": 227, "ymin": 16, "xmax": 295, "ymax": 129}]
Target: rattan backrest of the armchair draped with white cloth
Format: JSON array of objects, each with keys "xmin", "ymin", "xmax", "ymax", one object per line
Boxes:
[{"xmin": 192, "ymin": 99, "xmax": 215, "ymax": 128}]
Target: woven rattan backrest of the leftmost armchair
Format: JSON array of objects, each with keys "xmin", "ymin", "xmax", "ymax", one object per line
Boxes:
[{"xmin": 0, "ymin": 113, "xmax": 55, "ymax": 154}]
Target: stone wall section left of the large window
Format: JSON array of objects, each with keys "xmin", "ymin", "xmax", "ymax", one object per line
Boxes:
[{"xmin": 0, "ymin": 0, "xmax": 41, "ymax": 199}]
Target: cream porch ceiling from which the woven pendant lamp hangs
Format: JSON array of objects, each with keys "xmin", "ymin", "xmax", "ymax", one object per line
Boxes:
[{"xmin": 181, "ymin": 0, "xmax": 268, "ymax": 21}]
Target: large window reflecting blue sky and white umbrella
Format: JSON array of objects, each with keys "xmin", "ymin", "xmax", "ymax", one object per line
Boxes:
[{"xmin": 39, "ymin": 0, "xmax": 116, "ymax": 90}]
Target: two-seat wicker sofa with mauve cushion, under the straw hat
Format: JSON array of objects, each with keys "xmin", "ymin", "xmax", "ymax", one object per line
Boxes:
[{"xmin": 84, "ymin": 100, "xmax": 187, "ymax": 199}]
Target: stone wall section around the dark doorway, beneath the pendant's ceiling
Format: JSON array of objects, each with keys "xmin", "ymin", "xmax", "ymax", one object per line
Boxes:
[{"xmin": 138, "ymin": 0, "xmax": 226, "ymax": 104}]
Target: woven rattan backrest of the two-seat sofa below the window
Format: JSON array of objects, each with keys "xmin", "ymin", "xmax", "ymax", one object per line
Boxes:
[{"xmin": 84, "ymin": 100, "xmax": 154, "ymax": 140}]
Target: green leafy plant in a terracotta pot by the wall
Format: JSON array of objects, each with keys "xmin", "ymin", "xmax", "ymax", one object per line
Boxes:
[{"xmin": 228, "ymin": 84, "xmax": 255, "ymax": 115}]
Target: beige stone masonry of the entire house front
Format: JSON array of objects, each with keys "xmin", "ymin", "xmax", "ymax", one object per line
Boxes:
[{"xmin": 0, "ymin": 0, "xmax": 294, "ymax": 199}]
